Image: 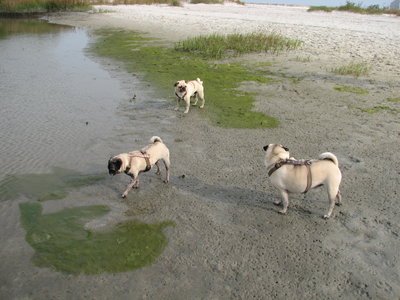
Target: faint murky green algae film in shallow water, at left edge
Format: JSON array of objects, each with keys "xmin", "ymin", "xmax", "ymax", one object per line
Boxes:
[{"xmin": 0, "ymin": 167, "xmax": 107, "ymax": 201}]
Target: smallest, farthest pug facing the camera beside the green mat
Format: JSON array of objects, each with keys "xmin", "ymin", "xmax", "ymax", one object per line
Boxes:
[{"xmin": 174, "ymin": 78, "xmax": 204, "ymax": 114}]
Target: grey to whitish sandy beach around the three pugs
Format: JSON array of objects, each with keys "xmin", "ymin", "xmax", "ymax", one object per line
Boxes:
[{"xmin": 3, "ymin": 3, "xmax": 400, "ymax": 299}]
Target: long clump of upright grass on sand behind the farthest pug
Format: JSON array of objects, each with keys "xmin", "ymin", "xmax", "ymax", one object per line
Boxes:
[{"xmin": 175, "ymin": 33, "xmax": 301, "ymax": 58}]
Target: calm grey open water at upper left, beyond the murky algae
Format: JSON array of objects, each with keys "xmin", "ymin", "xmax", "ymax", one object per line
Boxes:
[{"xmin": 0, "ymin": 19, "xmax": 127, "ymax": 179}]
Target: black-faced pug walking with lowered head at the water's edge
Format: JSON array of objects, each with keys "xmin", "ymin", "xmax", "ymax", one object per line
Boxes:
[{"xmin": 108, "ymin": 136, "xmax": 170, "ymax": 198}]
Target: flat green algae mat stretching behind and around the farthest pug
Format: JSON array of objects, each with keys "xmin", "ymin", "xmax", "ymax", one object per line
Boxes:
[{"xmin": 91, "ymin": 29, "xmax": 279, "ymax": 128}]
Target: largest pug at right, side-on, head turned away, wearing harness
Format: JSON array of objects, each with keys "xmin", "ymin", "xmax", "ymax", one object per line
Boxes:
[{"xmin": 264, "ymin": 144, "xmax": 342, "ymax": 219}]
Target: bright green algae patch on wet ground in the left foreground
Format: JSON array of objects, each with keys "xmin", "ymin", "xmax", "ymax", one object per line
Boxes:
[{"xmin": 20, "ymin": 202, "xmax": 176, "ymax": 275}]
